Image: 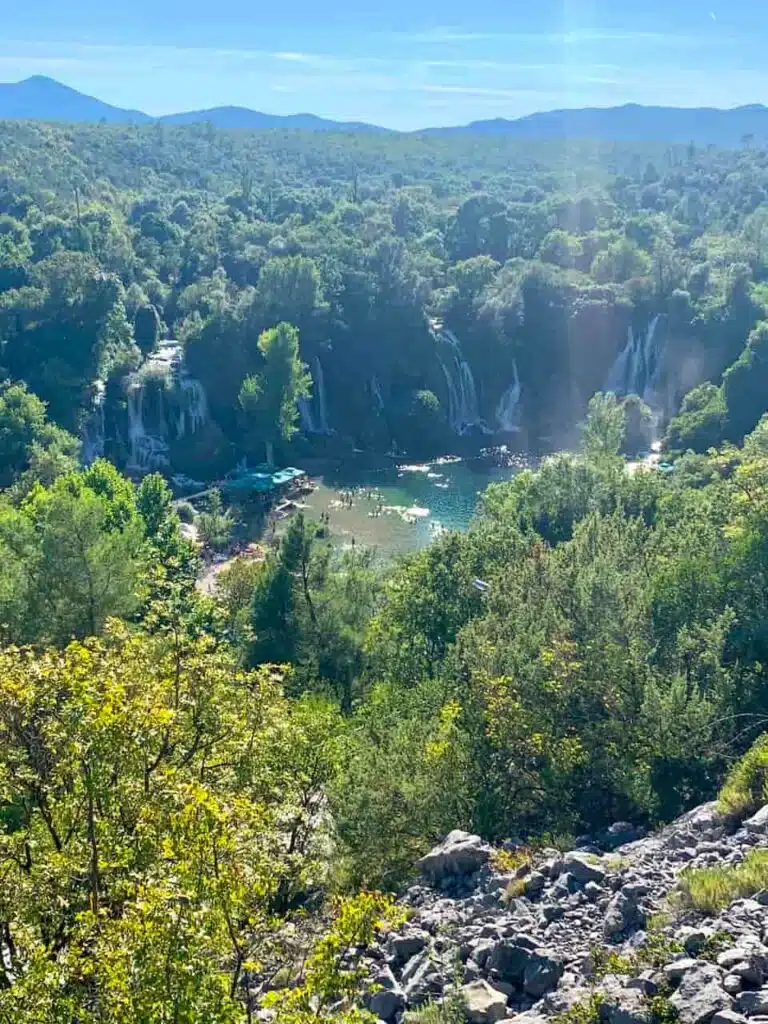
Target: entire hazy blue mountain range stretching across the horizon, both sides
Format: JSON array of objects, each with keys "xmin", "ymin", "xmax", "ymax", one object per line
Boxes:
[{"xmin": 0, "ymin": 75, "xmax": 768, "ymax": 146}]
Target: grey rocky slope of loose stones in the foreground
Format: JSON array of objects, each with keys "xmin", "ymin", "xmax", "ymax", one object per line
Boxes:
[{"xmin": 369, "ymin": 804, "xmax": 768, "ymax": 1024}]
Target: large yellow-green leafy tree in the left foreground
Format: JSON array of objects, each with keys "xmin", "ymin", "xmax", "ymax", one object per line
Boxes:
[{"xmin": 0, "ymin": 629, "xmax": 337, "ymax": 1024}]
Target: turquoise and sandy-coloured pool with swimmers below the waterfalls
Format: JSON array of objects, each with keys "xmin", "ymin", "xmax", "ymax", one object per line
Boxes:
[{"xmin": 296, "ymin": 456, "xmax": 525, "ymax": 558}]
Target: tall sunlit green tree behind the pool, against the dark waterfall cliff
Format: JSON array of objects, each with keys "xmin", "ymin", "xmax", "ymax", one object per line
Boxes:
[{"xmin": 239, "ymin": 324, "xmax": 311, "ymax": 466}]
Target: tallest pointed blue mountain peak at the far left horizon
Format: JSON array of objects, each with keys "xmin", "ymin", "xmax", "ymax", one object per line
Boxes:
[{"xmin": 0, "ymin": 75, "xmax": 152, "ymax": 124}]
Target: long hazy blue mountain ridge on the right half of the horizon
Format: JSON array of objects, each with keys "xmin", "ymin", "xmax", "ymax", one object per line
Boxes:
[{"xmin": 426, "ymin": 103, "xmax": 768, "ymax": 146}]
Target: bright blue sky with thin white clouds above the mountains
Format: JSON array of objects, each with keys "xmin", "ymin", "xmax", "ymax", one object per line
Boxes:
[{"xmin": 0, "ymin": 0, "xmax": 768, "ymax": 129}]
